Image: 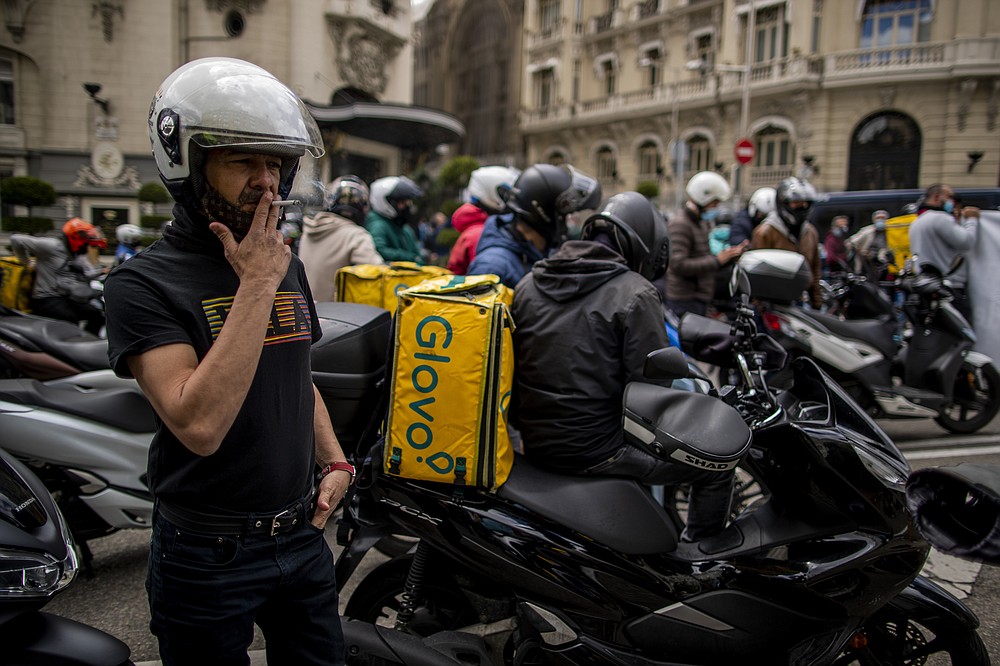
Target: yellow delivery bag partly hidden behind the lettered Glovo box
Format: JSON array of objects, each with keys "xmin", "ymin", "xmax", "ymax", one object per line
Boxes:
[{"xmin": 335, "ymin": 261, "xmax": 451, "ymax": 311}]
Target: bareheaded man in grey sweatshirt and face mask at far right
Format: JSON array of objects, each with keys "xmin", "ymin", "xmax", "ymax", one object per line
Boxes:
[{"xmin": 910, "ymin": 183, "xmax": 979, "ymax": 321}]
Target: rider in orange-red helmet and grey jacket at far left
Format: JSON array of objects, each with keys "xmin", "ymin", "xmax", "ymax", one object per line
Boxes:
[{"xmin": 10, "ymin": 217, "xmax": 108, "ymax": 335}]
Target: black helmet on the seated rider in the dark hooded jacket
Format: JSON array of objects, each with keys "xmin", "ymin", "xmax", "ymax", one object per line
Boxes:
[{"xmin": 580, "ymin": 192, "xmax": 670, "ymax": 282}]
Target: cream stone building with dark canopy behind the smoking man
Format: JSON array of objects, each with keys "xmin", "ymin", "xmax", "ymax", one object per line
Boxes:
[{"xmin": 0, "ymin": 0, "xmax": 461, "ymax": 231}]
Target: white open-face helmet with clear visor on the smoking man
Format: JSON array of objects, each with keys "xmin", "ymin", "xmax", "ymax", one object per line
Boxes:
[{"xmin": 149, "ymin": 58, "xmax": 324, "ymax": 202}]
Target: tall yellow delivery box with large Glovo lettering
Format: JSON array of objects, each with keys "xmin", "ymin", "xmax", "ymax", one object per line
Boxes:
[{"xmin": 384, "ymin": 275, "xmax": 514, "ymax": 491}]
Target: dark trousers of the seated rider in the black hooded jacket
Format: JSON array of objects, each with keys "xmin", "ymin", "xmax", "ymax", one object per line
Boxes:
[{"xmin": 582, "ymin": 444, "xmax": 736, "ymax": 541}]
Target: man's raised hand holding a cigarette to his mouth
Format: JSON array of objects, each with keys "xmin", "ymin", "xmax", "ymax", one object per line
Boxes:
[{"xmin": 208, "ymin": 191, "xmax": 292, "ymax": 291}]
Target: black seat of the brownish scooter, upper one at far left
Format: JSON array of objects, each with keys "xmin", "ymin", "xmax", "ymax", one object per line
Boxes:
[{"xmin": 0, "ymin": 315, "xmax": 111, "ymax": 372}]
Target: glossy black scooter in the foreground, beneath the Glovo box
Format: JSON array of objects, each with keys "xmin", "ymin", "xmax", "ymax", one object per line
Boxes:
[{"xmin": 328, "ymin": 272, "xmax": 989, "ymax": 666}]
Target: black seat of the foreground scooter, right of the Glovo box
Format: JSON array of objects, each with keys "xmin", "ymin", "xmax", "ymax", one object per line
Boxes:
[{"xmin": 497, "ymin": 455, "xmax": 677, "ymax": 555}]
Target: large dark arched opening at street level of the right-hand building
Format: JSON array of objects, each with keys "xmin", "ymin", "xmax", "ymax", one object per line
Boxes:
[{"xmin": 847, "ymin": 111, "xmax": 922, "ymax": 190}]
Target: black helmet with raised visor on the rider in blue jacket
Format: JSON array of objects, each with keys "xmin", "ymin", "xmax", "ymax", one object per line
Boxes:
[{"xmin": 506, "ymin": 164, "xmax": 601, "ymax": 241}]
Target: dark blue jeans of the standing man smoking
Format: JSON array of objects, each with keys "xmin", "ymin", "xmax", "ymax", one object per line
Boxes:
[{"xmin": 146, "ymin": 512, "xmax": 344, "ymax": 666}]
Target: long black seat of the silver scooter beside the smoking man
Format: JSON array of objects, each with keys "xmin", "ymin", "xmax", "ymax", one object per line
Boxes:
[{"xmin": 0, "ymin": 379, "xmax": 156, "ymax": 433}]
